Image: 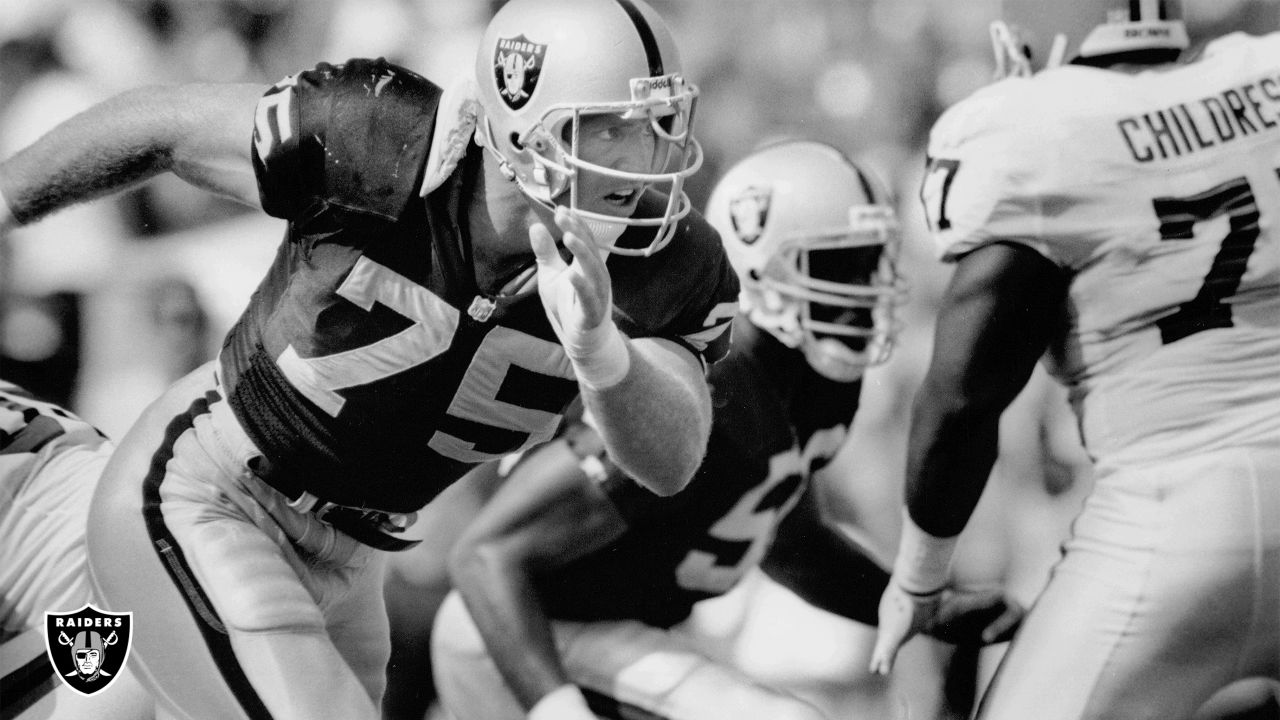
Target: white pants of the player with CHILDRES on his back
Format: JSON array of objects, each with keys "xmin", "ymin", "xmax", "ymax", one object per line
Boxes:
[{"xmin": 978, "ymin": 447, "xmax": 1280, "ymax": 720}]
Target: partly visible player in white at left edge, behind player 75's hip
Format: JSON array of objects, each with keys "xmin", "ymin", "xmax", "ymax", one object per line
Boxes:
[{"xmin": 0, "ymin": 380, "xmax": 154, "ymax": 720}]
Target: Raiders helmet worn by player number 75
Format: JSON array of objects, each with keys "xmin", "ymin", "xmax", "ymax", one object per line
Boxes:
[{"xmin": 475, "ymin": 0, "xmax": 703, "ymax": 255}]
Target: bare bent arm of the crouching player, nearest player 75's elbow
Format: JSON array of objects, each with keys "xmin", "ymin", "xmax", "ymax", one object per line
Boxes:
[{"xmin": 449, "ymin": 439, "xmax": 626, "ymax": 710}]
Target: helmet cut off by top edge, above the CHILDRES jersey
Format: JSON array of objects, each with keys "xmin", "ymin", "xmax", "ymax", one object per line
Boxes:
[{"xmin": 991, "ymin": 0, "xmax": 1190, "ymax": 78}]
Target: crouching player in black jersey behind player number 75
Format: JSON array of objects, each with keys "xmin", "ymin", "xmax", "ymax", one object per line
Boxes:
[{"xmin": 433, "ymin": 141, "xmax": 1020, "ymax": 720}]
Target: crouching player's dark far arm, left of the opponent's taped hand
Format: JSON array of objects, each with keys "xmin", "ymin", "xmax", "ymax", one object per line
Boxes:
[{"xmin": 760, "ymin": 486, "xmax": 888, "ymax": 626}]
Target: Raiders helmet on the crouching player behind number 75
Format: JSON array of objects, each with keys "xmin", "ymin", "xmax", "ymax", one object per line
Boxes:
[{"xmin": 707, "ymin": 141, "xmax": 906, "ymax": 382}]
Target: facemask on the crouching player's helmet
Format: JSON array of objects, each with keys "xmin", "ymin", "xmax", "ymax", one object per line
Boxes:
[{"xmin": 742, "ymin": 206, "xmax": 906, "ymax": 382}]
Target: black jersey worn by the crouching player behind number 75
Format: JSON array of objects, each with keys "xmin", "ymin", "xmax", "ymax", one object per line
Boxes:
[{"xmin": 538, "ymin": 318, "xmax": 860, "ymax": 626}]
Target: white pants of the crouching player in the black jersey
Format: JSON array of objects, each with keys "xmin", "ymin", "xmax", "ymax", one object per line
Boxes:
[{"xmin": 431, "ymin": 592, "xmax": 824, "ymax": 720}]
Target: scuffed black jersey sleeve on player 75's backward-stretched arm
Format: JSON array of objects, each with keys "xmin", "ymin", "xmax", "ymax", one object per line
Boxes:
[{"xmin": 252, "ymin": 59, "xmax": 440, "ymax": 220}]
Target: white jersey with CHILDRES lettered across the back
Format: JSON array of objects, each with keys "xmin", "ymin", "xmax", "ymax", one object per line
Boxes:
[{"xmin": 920, "ymin": 35, "xmax": 1280, "ymax": 460}]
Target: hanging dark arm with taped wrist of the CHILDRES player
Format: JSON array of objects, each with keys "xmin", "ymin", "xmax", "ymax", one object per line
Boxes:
[{"xmin": 870, "ymin": 242, "xmax": 1068, "ymax": 674}]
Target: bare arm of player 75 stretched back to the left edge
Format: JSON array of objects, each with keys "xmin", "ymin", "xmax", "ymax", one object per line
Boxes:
[{"xmin": 0, "ymin": 79, "xmax": 265, "ymax": 223}]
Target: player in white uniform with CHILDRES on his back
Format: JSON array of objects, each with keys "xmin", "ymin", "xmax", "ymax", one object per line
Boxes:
[{"xmin": 872, "ymin": 0, "xmax": 1280, "ymax": 720}]
